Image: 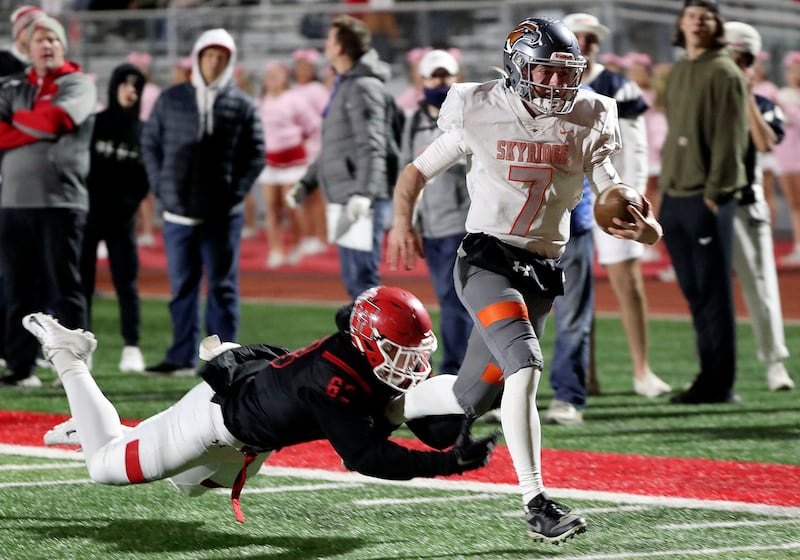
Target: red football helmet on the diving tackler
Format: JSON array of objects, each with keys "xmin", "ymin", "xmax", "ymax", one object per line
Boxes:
[{"xmin": 350, "ymin": 286, "xmax": 436, "ymax": 392}]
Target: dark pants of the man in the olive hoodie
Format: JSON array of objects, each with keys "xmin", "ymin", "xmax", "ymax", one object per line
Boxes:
[{"xmin": 659, "ymin": 195, "xmax": 738, "ymax": 398}]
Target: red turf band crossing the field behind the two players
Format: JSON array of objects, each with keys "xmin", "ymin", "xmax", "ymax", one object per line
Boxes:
[{"xmin": 0, "ymin": 410, "xmax": 800, "ymax": 507}]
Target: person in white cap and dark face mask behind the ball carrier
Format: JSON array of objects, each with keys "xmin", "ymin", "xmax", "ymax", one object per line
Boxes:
[{"xmin": 403, "ymin": 50, "xmax": 472, "ymax": 374}]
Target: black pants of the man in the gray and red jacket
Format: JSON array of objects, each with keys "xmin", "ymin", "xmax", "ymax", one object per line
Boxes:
[{"xmin": 0, "ymin": 208, "xmax": 86, "ymax": 379}]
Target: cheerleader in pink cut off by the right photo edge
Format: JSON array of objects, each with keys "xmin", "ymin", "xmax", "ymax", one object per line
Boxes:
[{"xmin": 773, "ymin": 51, "xmax": 800, "ymax": 266}]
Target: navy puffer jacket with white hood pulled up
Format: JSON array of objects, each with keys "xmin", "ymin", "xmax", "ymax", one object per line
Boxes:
[{"xmin": 142, "ymin": 29, "xmax": 265, "ymax": 221}]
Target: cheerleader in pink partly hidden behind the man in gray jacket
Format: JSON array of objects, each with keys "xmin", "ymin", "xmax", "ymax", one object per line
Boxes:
[{"xmin": 291, "ymin": 49, "xmax": 331, "ymax": 258}]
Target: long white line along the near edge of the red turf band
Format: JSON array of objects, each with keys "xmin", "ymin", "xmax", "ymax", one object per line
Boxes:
[{"xmin": 0, "ymin": 444, "xmax": 800, "ymax": 520}]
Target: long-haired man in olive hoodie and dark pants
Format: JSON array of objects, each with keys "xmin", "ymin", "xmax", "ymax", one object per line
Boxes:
[{"xmin": 659, "ymin": 0, "xmax": 749, "ymax": 404}]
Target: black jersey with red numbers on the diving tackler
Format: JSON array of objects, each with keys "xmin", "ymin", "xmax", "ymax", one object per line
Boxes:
[{"xmin": 222, "ymin": 332, "xmax": 458, "ymax": 479}]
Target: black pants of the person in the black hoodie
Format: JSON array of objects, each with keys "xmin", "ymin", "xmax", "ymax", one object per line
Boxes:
[{"xmin": 80, "ymin": 209, "xmax": 141, "ymax": 346}]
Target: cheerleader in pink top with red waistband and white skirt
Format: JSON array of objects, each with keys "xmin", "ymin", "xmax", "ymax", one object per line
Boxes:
[{"xmin": 259, "ymin": 61, "xmax": 322, "ymax": 268}]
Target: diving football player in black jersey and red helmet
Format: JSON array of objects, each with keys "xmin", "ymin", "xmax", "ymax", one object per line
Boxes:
[{"xmin": 23, "ymin": 286, "xmax": 498, "ymax": 522}]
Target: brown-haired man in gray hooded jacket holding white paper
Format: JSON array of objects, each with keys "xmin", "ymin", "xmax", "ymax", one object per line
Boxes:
[{"xmin": 287, "ymin": 16, "xmax": 394, "ymax": 299}]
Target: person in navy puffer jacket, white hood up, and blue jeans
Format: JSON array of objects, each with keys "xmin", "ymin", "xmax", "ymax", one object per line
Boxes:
[{"xmin": 142, "ymin": 29, "xmax": 265, "ymax": 375}]
